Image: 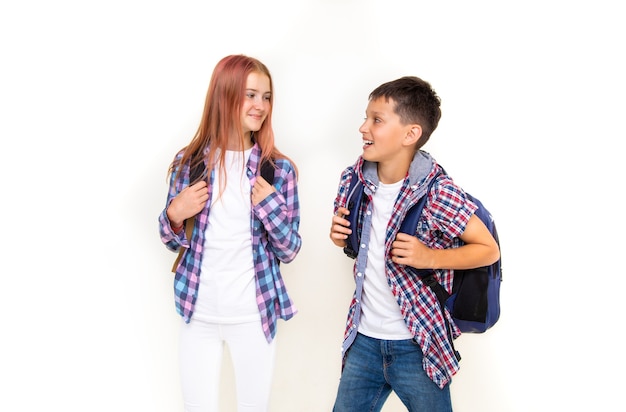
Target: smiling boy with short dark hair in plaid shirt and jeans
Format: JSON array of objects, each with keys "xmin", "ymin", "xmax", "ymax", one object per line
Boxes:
[{"xmin": 330, "ymin": 77, "xmax": 500, "ymax": 412}]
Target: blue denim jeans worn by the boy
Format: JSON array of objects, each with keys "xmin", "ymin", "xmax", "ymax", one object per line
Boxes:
[{"xmin": 333, "ymin": 333, "xmax": 452, "ymax": 412}]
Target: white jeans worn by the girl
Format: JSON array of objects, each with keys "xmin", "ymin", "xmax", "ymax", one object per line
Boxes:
[{"xmin": 180, "ymin": 319, "xmax": 276, "ymax": 412}]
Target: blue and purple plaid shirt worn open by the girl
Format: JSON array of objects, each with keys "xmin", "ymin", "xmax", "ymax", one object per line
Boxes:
[{"xmin": 159, "ymin": 144, "xmax": 302, "ymax": 342}]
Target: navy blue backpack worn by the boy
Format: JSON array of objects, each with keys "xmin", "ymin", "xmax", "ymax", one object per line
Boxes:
[{"xmin": 344, "ymin": 171, "xmax": 502, "ymax": 360}]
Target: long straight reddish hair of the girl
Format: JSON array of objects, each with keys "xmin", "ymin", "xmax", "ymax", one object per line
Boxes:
[{"xmin": 169, "ymin": 54, "xmax": 297, "ymax": 183}]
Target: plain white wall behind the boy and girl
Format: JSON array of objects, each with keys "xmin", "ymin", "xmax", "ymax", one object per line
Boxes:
[{"xmin": 0, "ymin": 0, "xmax": 626, "ymax": 412}]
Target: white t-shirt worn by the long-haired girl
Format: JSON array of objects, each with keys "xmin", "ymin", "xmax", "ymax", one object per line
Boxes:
[{"xmin": 193, "ymin": 149, "xmax": 260, "ymax": 323}]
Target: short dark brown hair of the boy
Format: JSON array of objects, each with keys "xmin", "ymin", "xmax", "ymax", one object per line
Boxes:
[{"xmin": 369, "ymin": 76, "xmax": 441, "ymax": 149}]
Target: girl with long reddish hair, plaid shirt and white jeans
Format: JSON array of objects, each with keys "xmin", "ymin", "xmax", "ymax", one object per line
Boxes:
[{"xmin": 159, "ymin": 55, "xmax": 302, "ymax": 412}]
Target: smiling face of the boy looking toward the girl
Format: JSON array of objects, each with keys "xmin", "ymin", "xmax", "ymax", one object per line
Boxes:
[{"xmin": 359, "ymin": 97, "xmax": 413, "ymax": 163}]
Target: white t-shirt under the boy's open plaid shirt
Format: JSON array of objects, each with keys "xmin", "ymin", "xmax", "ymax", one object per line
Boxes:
[{"xmin": 359, "ymin": 180, "xmax": 413, "ymax": 340}]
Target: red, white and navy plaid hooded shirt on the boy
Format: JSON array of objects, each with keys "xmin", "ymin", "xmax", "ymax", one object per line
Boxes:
[{"xmin": 334, "ymin": 151, "xmax": 476, "ymax": 387}]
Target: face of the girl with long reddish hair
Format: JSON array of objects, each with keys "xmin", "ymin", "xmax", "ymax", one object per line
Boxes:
[{"xmin": 241, "ymin": 72, "xmax": 272, "ymax": 135}]
